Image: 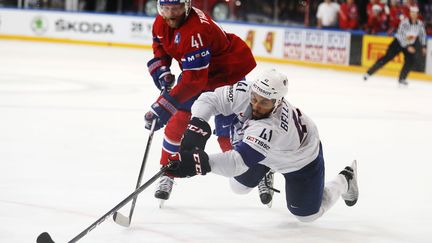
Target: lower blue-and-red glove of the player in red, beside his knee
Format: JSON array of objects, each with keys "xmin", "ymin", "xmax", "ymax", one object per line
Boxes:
[{"xmin": 144, "ymin": 92, "xmax": 178, "ymax": 131}]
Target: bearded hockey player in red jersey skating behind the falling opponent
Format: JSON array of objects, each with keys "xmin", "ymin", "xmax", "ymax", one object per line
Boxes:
[{"xmin": 145, "ymin": 0, "xmax": 256, "ymax": 200}]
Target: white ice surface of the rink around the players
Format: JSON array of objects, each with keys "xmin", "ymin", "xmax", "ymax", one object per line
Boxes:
[{"xmin": 0, "ymin": 41, "xmax": 432, "ymax": 243}]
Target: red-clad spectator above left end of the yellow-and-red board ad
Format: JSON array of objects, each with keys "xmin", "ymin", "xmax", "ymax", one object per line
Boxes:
[{"xmin": 366, "ymin": 0, "xmax": 387, "ymax": 34}]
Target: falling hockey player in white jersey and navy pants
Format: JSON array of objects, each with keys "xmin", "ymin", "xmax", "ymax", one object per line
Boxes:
[{"xmin": 168, "ymin": 70, "xmax": 358, "ymax": 222}]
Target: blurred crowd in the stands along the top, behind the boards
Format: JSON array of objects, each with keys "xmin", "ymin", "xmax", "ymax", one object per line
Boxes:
[{"xmin": 0, "ymin": 0, "xmax": 432, "ymax": 35}]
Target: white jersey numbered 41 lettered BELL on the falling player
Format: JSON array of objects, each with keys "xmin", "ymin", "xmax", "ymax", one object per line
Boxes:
[{"xmin": 192, "ymin": 81, "xmax": 320, "ymax": 176}]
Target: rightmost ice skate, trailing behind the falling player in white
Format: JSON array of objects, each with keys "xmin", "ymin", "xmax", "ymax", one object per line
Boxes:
[{"xmin": 339, "ymin": 160, "xmax": 359, "ymax": 207}]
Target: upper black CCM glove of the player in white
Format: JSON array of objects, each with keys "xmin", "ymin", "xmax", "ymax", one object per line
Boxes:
[{"xmin": 180, "ymin": 117, "xmax": 211, "ymax": 151}]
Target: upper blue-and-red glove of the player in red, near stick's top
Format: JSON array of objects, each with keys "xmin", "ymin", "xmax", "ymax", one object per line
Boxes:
[{"xmin": 147, "ymin": 57, "xmax": 175, "ymax": 90}]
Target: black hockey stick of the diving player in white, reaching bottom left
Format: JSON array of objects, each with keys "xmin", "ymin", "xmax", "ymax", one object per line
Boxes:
[{"xmin": 36, "ymin": 161, "xmax": 178, "ymax": 243}]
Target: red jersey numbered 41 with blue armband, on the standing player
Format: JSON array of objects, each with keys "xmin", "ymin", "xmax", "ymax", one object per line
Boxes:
[{"xmin": 153, "ymin": 8, "xmax": 256, "ymax": 103}]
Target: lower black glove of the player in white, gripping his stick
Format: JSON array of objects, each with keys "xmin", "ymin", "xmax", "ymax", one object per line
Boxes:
[{"xmin": 167, "ymin": 149, "xmax": 211, "ymax": 178}]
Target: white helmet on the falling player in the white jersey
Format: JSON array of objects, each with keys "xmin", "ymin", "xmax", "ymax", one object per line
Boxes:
[{"xmin": 252, "ymin": 69, "xmax": 288, "ymax": 104}]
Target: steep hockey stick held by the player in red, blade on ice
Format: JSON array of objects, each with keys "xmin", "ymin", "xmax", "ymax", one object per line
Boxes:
[{"xmin": 113, "ymin": 119, "xmax": 157, "ymax": 227}]
